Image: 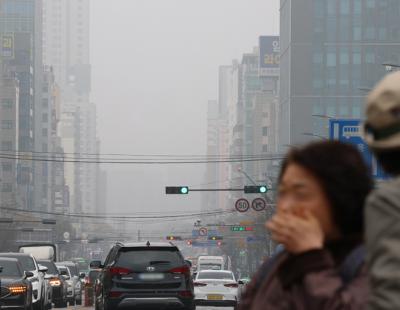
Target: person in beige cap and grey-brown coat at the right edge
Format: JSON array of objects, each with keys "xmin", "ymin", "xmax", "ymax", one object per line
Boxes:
[{"xmin": 365, "ymin": 72, "xmax": 400, "ymax": 310}]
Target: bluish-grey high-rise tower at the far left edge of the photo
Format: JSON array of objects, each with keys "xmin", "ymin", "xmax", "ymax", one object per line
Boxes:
[{"xmin": 0, "ymin": 0, "xmax": 42, "ymax": 209}]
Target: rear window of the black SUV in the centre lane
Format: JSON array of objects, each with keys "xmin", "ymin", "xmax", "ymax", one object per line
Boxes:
[{"xmin": 116, "ymin": 247, "xmax": 184, "ymax": 270}]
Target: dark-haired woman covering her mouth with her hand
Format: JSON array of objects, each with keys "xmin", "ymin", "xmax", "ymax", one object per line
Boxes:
[{"xmin": 240, "ymin": 141, "xmax": 372, "ymax": 310}]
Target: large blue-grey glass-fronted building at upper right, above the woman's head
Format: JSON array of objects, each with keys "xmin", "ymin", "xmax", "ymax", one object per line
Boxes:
[{"xmin": 280, "ymin": 0, "xmax": 400, "ymax": 150}]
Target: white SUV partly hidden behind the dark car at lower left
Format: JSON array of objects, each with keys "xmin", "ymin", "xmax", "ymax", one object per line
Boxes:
[{"xmin": 0, "ymin": 253, "xmax": 49, "ymax": 310}]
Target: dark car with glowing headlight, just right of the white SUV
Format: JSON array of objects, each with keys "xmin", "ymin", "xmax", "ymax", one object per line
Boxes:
[{"xmin": 38, "ymin": 260, "xmax": 68, "ymax": 308}]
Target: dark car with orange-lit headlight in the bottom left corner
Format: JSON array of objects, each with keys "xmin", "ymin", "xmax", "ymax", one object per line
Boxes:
[{"xmin": 0, "ymin": 257, "xmax": 33, "ymax": 310}]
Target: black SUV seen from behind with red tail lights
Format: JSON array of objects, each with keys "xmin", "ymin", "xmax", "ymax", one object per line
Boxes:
[{"xmin": 90, "ymin": 242, "xmax": 195, "ymax": 310}]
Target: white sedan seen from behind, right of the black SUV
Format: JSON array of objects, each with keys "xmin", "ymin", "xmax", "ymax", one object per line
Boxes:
[{"xmin": 194, "ymin": 270, "xmax": 238, "ymax": 308}]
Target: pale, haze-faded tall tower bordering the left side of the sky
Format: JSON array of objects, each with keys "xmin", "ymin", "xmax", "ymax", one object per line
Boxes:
[{"xmin": 43, "ymin": 0, "xmax": 99, "ymax": 212}]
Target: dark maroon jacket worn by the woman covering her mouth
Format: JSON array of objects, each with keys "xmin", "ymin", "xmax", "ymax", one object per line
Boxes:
[{"xmin": 239, "ymin": 242, "xmax": 368, "ymax": 310}]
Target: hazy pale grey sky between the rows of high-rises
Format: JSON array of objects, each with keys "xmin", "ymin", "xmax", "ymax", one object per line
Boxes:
[{"xmin": 91, "ymin": 0, "xmax": 279, "ymax": 222}]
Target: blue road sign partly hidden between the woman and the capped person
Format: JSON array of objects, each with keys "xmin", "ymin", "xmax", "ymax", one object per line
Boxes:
[{"xmin": 329, "ymin": 119, "xmax": 387, "ymax": 179}]
